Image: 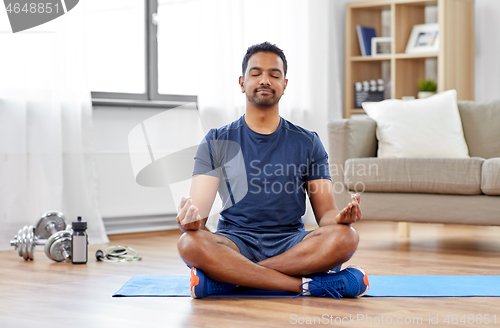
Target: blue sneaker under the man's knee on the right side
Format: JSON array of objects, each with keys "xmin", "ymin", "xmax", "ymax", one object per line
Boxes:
[{"xmin": 298, "ymin": 265, "xmax": 370, "ymax": 299}]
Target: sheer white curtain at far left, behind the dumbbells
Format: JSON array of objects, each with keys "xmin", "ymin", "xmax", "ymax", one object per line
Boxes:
[{"xmin": 0, "ymin": 5, "xmax": 108, "ymax": 250}]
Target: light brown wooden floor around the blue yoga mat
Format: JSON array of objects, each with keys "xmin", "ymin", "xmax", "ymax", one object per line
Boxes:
[{"xmin": 0, "ymin": 222, "xmax": 500, "ymax": 328}]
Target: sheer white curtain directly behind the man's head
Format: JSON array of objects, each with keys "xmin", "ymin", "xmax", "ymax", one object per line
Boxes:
[{"xmin": 199, "ymin": 0, "xmax": 341, "ymax": 142}]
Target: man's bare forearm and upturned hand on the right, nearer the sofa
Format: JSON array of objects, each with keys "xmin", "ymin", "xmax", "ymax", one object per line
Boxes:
[{"xmin": 306, "ymin": 179, "xmax": 361, "ymax": 227}]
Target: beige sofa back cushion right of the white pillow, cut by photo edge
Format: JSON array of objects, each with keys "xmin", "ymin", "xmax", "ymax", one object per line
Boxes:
[{"xmin": 458, "ymin": 100, "xmax": 500, "ymax": 158}]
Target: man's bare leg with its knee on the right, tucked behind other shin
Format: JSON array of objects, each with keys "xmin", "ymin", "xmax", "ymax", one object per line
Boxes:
[{"xmin": 257, "ymin": 224, "xmax": 359, "ymax": 276}]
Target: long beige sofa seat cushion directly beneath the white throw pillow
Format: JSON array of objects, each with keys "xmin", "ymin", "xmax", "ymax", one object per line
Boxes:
[{"xmin": 344, "ymin": 157, "xmax": 484, "ymax": 195}]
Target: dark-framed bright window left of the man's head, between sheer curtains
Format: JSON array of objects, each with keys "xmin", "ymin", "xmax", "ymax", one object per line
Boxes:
[{"xmin": 84, "ymin": 0, "xmax": 199, "ymax": 103}]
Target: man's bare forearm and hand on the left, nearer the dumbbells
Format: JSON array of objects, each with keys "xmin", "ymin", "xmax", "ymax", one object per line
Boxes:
[{"xmin": 177, "ymin": 174, "xmax": 219, "ymax": 232}]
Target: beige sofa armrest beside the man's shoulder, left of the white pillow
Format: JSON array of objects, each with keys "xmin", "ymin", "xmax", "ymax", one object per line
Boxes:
[{"xmin": 328, "ymin": 119, "xmax": 377, "ymax": 182}]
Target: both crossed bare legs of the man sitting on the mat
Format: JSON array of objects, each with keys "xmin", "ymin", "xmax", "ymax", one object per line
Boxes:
[{"xmin": 178, "ymin": 225, "xmax": 359, "ymax": 293}]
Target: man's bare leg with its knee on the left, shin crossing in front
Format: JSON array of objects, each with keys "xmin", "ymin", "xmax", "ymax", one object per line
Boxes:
[{"xmin": 177, "ymin": 230, "xmax": 302, "ymax": 293}]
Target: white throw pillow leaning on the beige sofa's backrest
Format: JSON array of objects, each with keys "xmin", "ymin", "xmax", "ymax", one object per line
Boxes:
[{"xmin": 363, "ymin": 90, "xmax": 469, "ymax": 158}]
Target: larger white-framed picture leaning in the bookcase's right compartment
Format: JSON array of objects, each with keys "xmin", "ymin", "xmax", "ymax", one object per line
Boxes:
[{"xmin": 405, "ymin": 23, "xmax": 439, "ymax": 53}]
